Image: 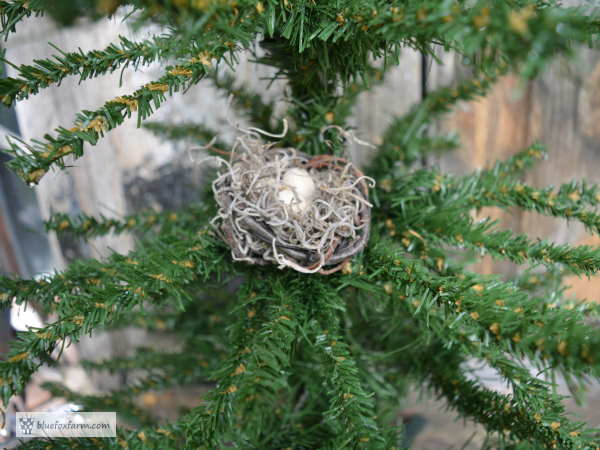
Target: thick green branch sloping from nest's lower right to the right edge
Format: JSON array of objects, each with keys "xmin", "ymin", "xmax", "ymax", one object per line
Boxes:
[{"xmin": 360, "ymin": 239, "xmax": 600, "ymax": 377}]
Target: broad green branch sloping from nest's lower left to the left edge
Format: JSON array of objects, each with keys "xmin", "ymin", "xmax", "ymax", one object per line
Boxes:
[{"xmin": 0, "ymin": 230, "xmax": 224, "ymax": 403}]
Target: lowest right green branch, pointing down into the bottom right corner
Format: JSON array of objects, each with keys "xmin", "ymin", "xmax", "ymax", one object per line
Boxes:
[{"xmin": 400, "ymin": 340, "xmax": 594, "ymax": 449}]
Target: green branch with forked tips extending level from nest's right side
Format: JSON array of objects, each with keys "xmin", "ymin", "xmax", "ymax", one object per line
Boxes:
[{"xmin": 377, "ymin": 144, "xmax": 600, "ymax": 244}]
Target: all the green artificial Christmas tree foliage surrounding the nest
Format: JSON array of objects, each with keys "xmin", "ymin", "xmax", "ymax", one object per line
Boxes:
[{"xmin": 0, "ymin": 0, "xmax": 600, "ymax": 449}]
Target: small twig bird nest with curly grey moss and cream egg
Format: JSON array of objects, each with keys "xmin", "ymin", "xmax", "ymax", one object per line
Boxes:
[{"xmin": 212, "ymin": 134, "xmax": 374, "ymax": 274}]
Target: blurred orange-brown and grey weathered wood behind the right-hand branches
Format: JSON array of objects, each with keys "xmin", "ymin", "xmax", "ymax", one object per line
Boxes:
[{"xmin": 430, "ymin": 50, "xmax": 600, "ymax": 298}]
